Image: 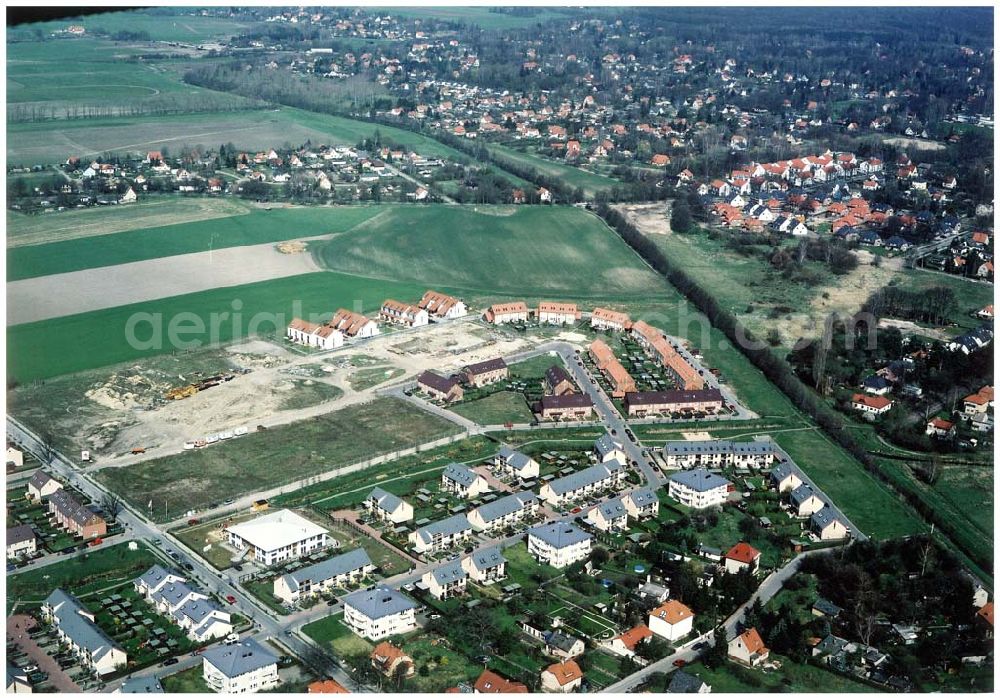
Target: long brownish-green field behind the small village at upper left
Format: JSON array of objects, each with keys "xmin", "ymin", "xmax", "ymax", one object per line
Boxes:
[{"xmin": 7, "ymin": 104, "xmax": 468, "ymax": 165}]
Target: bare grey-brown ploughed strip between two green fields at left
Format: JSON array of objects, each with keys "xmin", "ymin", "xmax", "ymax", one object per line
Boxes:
[{"xmin": 7, "ymin": 243, "xmax": 321, "ymax": 327}]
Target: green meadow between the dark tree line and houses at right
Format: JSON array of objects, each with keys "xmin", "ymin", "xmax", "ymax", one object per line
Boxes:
[{"xmin": 773, "ymin": 430, "xmax": 924, "ymax": 539}]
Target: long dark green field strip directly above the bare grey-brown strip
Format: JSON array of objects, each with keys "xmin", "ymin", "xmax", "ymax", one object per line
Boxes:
[{"xmin": 7, "ymin": 206, "xmax": 395, "ymax": 281}]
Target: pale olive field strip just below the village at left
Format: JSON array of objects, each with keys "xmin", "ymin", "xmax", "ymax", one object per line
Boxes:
[{"xmin": 7, "ymin": 196, "xmax": 253, "ymax": 247}]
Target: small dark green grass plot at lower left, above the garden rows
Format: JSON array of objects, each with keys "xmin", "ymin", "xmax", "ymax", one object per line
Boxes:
[{"xmin": 7, "ymin": 543, "xmax": 160, "ymax": 607}]
